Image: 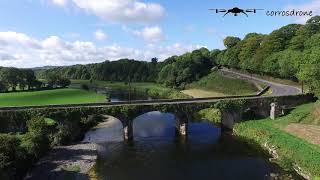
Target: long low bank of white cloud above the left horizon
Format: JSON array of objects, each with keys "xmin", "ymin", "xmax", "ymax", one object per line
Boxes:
[{"xmin": 0, "ymin": 31, "xmax": 203, "ymax": 67}]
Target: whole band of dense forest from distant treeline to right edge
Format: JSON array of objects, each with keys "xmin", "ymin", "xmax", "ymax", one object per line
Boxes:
[{"xmin": 32, "ymin": 16, "xmax": 320, "ymax": 97}]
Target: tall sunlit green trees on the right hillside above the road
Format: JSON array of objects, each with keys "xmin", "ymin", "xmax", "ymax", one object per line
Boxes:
[{"xmin": 210, "ymin": 16, "xmax": 320, "ymax": 95}]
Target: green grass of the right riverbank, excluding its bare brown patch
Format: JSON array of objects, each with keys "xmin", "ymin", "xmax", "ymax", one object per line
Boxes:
[{"xmin": 235, "ymin": 104, "xmax": 320, "ymax": 179}]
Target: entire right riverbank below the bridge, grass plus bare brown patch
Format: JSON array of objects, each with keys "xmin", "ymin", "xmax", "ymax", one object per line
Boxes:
[{"xmin": 235, "ymin": 103, "xmax": 320, "ymax": 179}]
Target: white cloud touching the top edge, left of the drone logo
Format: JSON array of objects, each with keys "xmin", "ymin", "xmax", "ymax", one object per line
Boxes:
[{"xmin": 72, "ymin": 0, "xmax": 165, "ymax": 23}]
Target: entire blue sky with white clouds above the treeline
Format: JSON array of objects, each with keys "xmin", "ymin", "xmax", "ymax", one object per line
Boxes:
[{"xmin": 0, "ymin": 0, "xmax": 320, "ymax": 67}]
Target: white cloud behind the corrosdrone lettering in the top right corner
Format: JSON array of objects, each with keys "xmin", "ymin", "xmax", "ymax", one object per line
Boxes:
[{"xmin": 285, "ymin": 0, "xmax": 320, "ymax": 24}]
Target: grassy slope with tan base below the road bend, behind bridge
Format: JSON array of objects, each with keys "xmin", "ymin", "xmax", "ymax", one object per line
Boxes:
[{"xmin": 186, "ymin": 72, "xmax": 258, "ymax": 97}]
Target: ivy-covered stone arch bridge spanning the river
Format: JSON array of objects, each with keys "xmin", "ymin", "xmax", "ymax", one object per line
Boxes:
[{"xmin": 0, "ymin": 95, "xmax": 315, "ymax": 140}]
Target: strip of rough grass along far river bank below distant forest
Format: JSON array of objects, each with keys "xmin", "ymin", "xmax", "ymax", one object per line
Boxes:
[{"xmin": 72, "ymin": 80, "xmax": 190, "ymax": 99}]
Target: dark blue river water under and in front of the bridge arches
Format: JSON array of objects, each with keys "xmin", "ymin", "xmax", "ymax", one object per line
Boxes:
[{"xmin": 85, "ymin": 112, "xmax": 298, "ymax": 180}]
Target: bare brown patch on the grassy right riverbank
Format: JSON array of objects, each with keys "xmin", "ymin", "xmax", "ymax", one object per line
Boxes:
[{"xmin": 285, "ymin": 124, "xmax": 320, "ymax": 145}]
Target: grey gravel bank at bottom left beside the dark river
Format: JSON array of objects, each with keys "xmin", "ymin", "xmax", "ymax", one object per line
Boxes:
[{"xmin": 25, "ymin": 143, "xmax": 97, "ymax": 180}]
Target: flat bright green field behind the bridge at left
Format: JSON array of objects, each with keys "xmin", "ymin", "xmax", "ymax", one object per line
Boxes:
[{"xmin": 0, "ymin": 89, "xmax": 106, "ymax": 106}]
